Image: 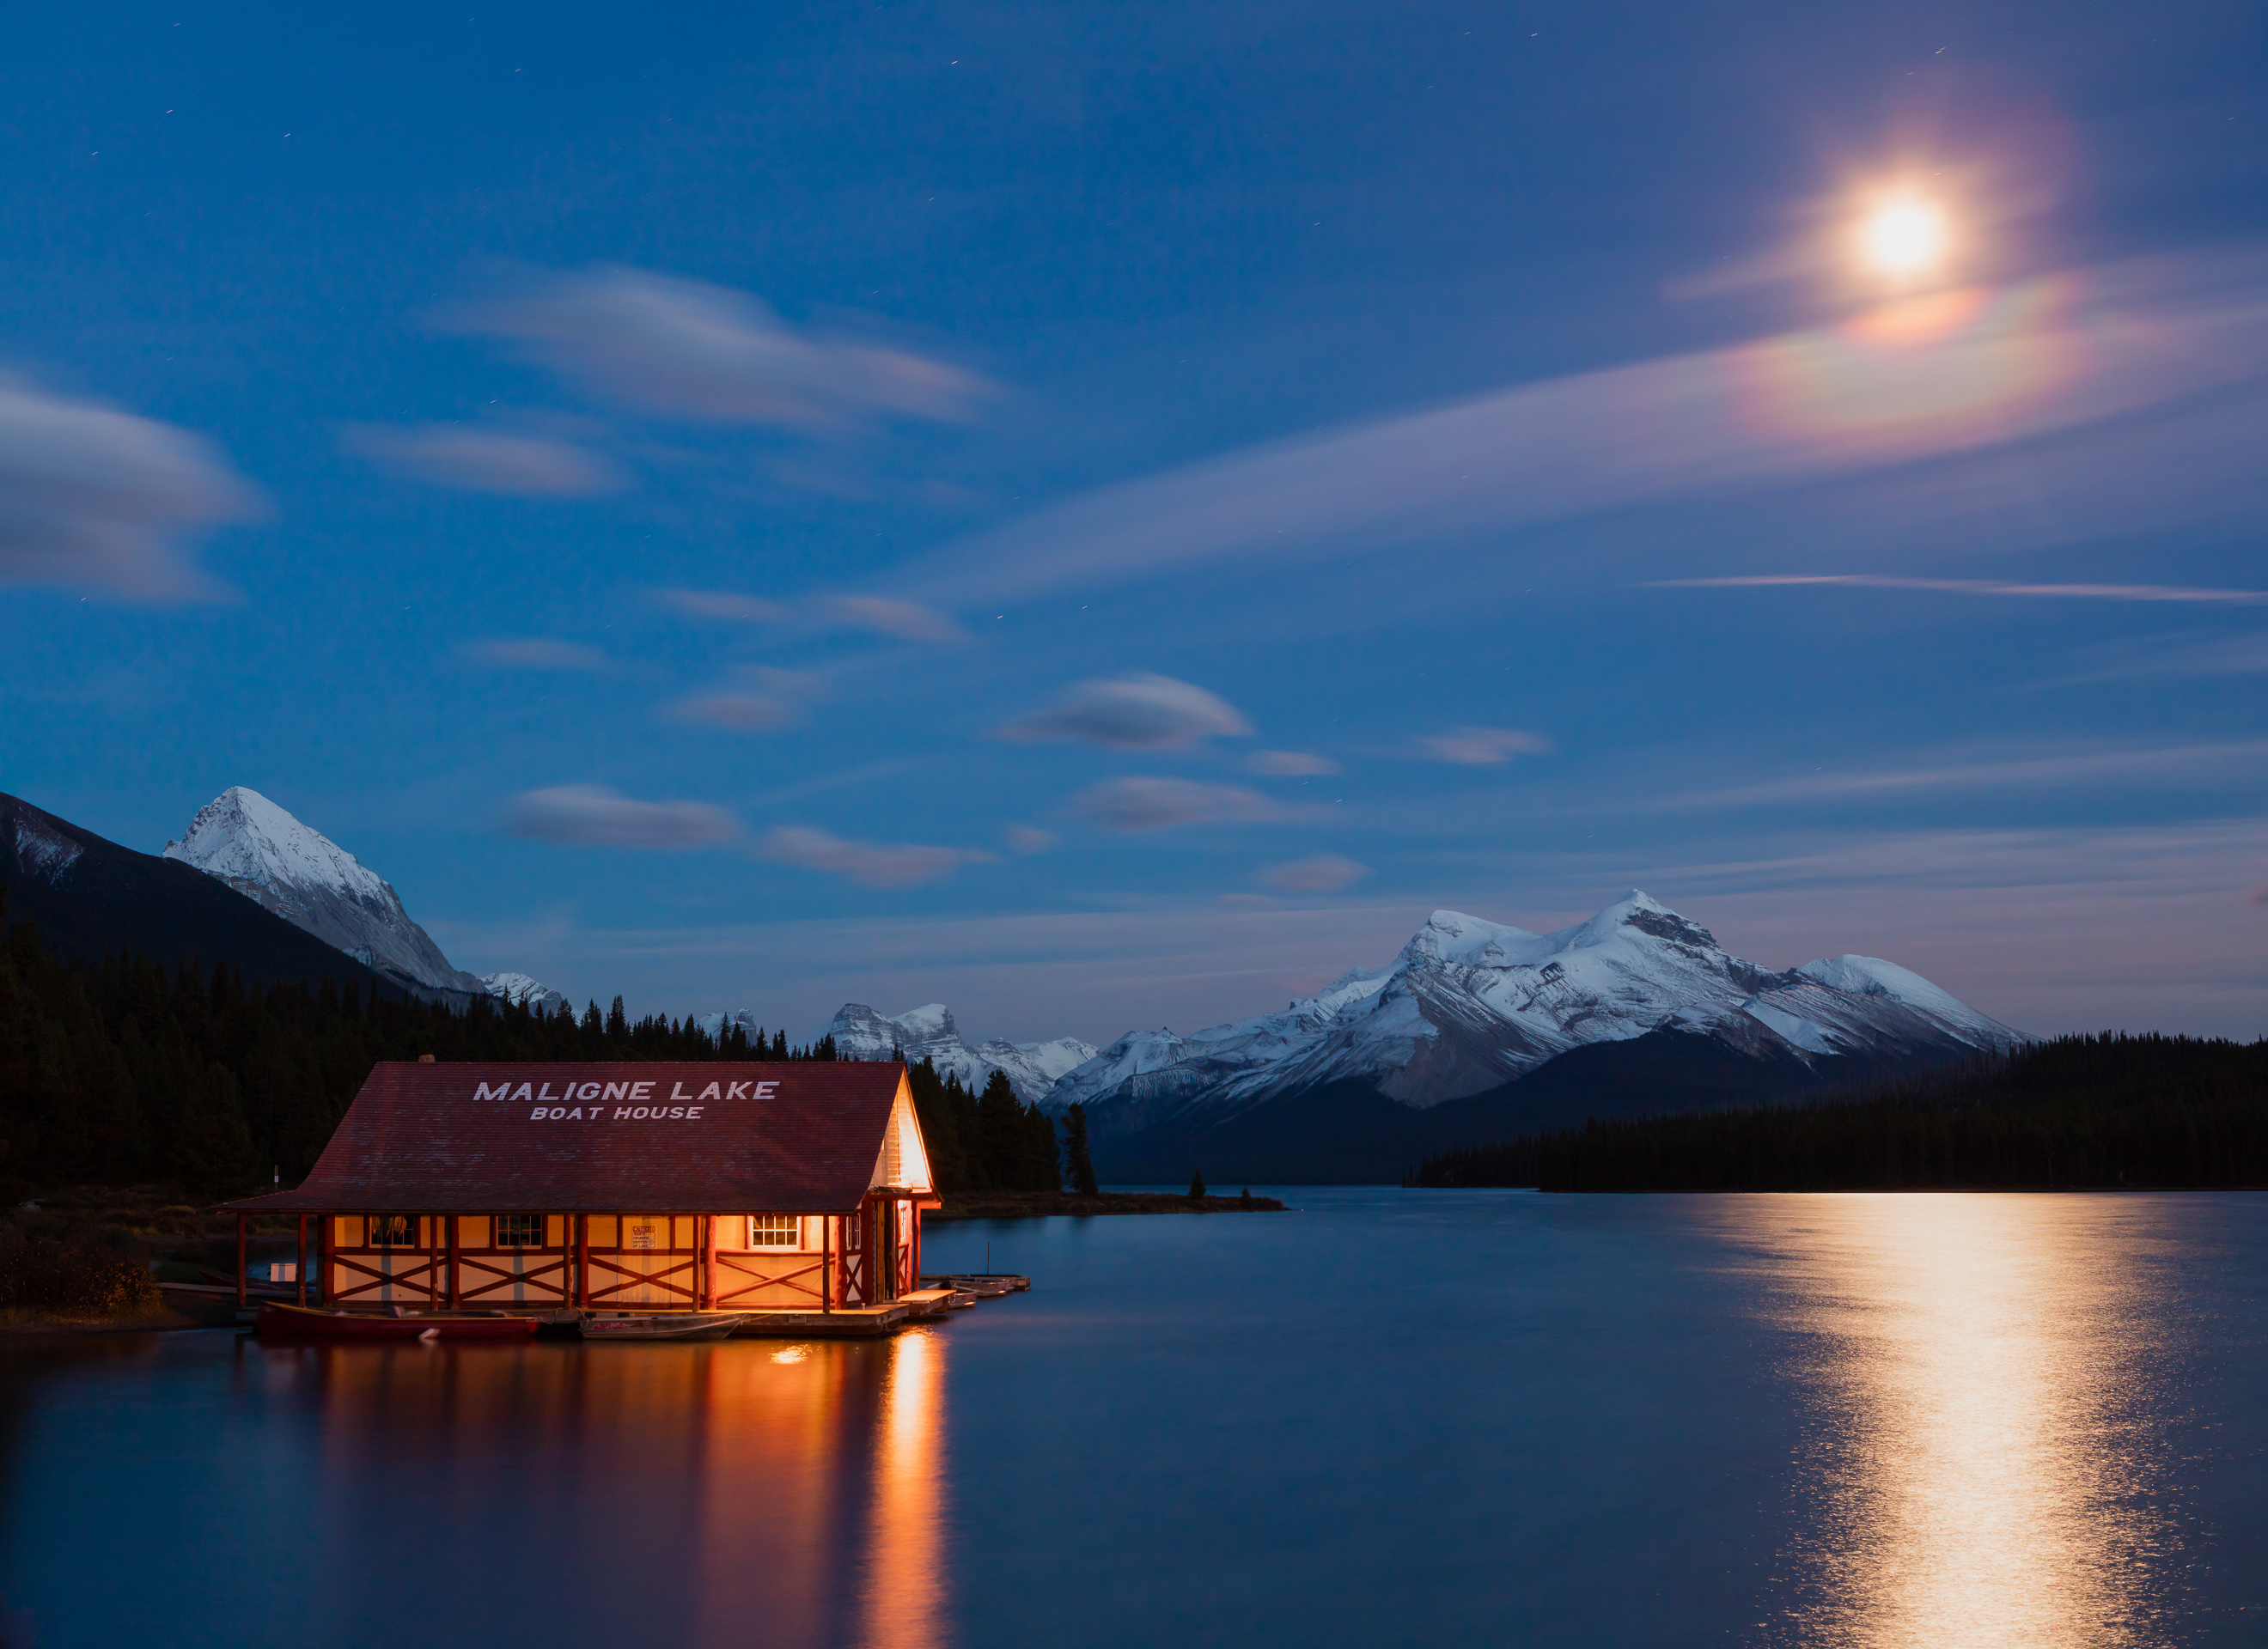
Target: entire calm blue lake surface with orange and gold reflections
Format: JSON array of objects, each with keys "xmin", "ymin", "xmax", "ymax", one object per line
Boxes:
[{"xmin": 0, "ymin": 1189, "xmax": 2268, "ymax": 1649}]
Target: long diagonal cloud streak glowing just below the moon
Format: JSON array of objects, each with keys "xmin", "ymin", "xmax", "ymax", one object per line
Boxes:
[{"xmin": 911, "ymin": 247, "xmax": 2268, "ymax": 592}]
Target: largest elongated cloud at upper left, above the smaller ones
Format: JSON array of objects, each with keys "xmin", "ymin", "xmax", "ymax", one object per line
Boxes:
[{"xmin": 440, "ymin": 265, "xmax": 993, "ymax": 429}]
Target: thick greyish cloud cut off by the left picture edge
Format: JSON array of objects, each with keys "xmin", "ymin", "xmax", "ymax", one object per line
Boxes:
[{"xmin": 0, "ymin": 376, "xmax": 261, "ymax": 601}]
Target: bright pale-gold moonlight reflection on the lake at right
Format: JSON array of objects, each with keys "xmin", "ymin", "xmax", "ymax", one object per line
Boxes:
[{"xmin": 1719, "ymin": 1196, "xmax": 2161, "ymax": 1649}]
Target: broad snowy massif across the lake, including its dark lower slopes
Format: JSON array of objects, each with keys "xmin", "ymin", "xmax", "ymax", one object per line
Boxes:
[{"xmin": 1043, "ymin": 889, "xmax": 2030, "ymax": 1179}]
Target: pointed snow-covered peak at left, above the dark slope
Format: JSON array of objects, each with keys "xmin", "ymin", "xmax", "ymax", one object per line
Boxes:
[{"xmin": 163, "ymin": 785, "xmax": 488, "ymax": 995}]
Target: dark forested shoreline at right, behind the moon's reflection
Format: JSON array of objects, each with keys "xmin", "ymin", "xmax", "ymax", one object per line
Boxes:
[{"xmin": 1406, "ymin": 1034, "xmax": 2268, "ymax": 1191}]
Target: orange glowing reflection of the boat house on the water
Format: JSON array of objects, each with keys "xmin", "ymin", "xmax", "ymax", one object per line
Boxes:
[{"xmin": 270, "ymin": 1331, "xmax": 950, "ymax": 1649}]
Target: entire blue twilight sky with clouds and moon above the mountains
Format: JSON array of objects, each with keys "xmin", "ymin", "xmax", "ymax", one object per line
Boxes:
[{"xmin": 0, "ymin": 0, "xmax": 2268, "ymax": 1041}]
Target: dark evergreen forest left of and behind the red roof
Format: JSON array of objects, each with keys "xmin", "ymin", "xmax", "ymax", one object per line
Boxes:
[{"xmin": 0, "ymin": 887, "xmax": 835, "ymax": 1196}]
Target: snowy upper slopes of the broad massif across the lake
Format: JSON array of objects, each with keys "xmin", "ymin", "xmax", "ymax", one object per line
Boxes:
[{"xmin": 1046, "ymin": 891, "xmax": 2023, "ymax": 1132}]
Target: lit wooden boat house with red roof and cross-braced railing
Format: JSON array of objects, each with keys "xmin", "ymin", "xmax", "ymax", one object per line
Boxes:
[{"xmin": 224, "ymin": 1062, "xmax": 936, "ymax": 1327}]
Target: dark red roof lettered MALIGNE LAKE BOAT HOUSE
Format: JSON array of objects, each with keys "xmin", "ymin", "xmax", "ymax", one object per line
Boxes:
[{"xmin": 227, "ymin": 1062, "xmax": 905, "ymax": 1214}]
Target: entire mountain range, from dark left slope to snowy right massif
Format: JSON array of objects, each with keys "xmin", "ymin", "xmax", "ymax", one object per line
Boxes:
[{"xmin": 0, "ymin": 785, "xmax": 2030, "ymax": 1184}]
